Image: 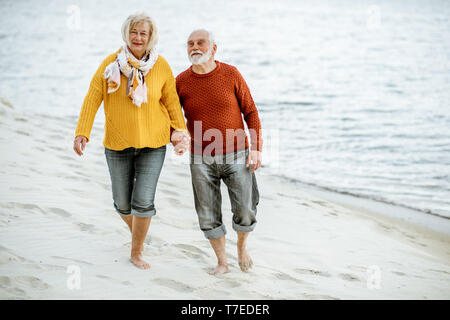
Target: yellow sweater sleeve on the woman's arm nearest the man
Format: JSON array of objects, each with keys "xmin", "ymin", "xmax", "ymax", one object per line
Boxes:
[{"xmin": 161, "ymin": 58, "xmax": 187, "ymax": 131}]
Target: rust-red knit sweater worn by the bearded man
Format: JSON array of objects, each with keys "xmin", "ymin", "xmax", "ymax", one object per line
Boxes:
[{"xmin": 176, "ymin": 61, "xmax": 262, "ymax": 155}]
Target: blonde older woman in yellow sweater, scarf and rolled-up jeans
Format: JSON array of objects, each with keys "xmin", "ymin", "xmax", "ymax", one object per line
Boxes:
[{"xmin": 73, "ymin": 13, "xmax": 189, "ymax": 269}]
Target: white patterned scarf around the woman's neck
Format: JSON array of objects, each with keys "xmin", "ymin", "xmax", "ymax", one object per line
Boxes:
[{"xmin": 103, "ymin": 45, "xmax": 158, "ymax": 107}]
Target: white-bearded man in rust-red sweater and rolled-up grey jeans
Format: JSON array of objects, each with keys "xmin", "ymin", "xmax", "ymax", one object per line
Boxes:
[{"xmin": 176, "ymin": 29, "xmax": 262, "ymax": 275}]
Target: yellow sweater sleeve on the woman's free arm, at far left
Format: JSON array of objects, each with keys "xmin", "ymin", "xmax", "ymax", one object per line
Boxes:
[{"xmin": 75, "ymin": 62, "xmax": 105, "ymax": 142}]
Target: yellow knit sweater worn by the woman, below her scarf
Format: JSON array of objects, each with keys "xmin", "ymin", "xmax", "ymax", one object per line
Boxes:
[{"xmin": 75, "ymin": 52, "xmax": 186, "ymax": 150}]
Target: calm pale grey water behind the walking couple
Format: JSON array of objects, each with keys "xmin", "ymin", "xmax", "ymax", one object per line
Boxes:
[{"xmin": 0, "ymin": 0, "xmax": 450, "ymax": 217}]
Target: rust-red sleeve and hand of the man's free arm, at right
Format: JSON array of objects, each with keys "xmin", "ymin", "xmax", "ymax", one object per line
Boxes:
[{"xmin": 235, "ymin": 68, "xmax": 263, "ymax": 151}]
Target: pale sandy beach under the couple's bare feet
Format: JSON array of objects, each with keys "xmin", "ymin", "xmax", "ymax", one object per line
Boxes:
[{"xmin": 0, "ymin": 101, "xmax": 450, "ymax": 300}]
